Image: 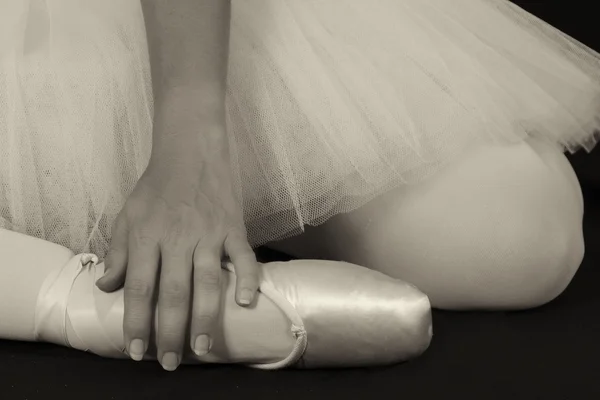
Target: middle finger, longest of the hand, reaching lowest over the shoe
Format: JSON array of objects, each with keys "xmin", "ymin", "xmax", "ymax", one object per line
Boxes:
[{"xmin": 156, "ymin": 237, "xmax": 193, "ymax": 371}]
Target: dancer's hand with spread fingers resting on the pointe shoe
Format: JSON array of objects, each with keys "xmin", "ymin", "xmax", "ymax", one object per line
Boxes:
[{"xmin": 97, "ymin": 132, "xmax": 259, "ymax": 370}]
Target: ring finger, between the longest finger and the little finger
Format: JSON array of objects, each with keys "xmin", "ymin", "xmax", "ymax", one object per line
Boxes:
[{"xmin": 190, "ymin": 244, "xmax": 221, "ymax": 356}]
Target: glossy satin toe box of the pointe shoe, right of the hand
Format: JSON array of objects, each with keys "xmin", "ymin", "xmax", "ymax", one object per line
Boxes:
[{"xmin": 263, "ymin": 260, "xmax": 432, "ymax": 368}]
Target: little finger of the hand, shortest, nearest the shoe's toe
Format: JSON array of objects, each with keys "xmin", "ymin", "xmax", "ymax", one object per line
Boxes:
[{"xmin": 225, "ymin": 230, "xmax": 260, "ymax": 306}]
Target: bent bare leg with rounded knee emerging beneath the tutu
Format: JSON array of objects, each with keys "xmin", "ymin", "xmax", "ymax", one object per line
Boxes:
[{"xmin": 269, "ymin": 140, "xmax": 584, "ymax": 309}]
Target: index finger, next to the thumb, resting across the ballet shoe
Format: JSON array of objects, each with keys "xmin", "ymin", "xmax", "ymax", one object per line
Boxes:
[{"xmin": 123, "ymin": 231, "xmax": 160, "ymax": 361}]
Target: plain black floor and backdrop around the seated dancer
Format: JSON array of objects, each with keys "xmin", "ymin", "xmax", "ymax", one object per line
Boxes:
[{"xmin": 0, "ymin": 0, "xmax": 600, "ymax": 400}]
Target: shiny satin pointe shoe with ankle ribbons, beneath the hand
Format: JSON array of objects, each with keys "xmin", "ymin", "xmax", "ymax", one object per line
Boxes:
[{"xmin": 23, "ymin": 236, "xmax": 432, "ymax": 369}]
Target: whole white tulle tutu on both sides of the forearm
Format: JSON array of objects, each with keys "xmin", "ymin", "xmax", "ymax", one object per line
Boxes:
[{"xmin": 0, "ymin": 0, "xmax": 600, "ymax": 258}]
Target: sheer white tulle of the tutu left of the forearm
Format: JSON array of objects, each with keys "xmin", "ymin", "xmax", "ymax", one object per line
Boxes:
[{"xmin": 0, "ymin": 0, "xmax": 152, "ymax": 254}]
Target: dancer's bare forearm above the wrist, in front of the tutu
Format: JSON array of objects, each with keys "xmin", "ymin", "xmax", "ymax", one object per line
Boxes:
[{"xmin": 142, "ymin": 0, "xmax": 231, "ymax": 153}]
